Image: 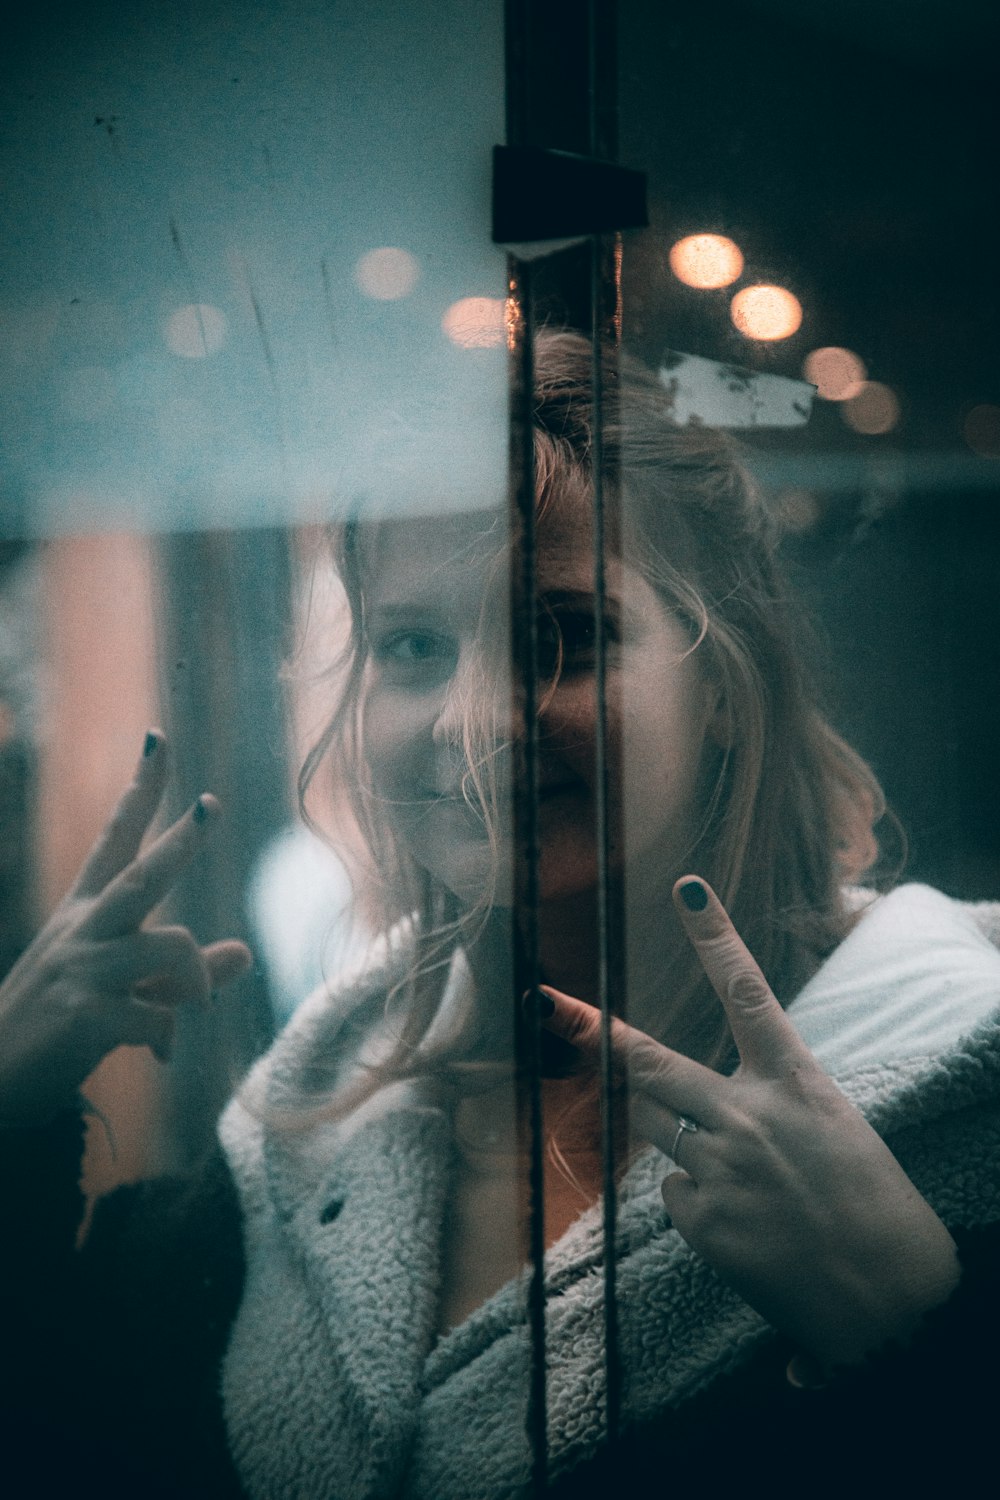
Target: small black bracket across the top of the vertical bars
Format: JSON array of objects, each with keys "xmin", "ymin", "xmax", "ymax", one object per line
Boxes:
[{"xmin": 493, "ymin": 146, "xmax": 649, "ymax": 245}]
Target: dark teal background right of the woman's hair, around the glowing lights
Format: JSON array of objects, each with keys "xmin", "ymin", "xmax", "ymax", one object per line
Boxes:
[{"xmin": 528, "ymin": 0, "xmax": 1000, "ymax": 897}]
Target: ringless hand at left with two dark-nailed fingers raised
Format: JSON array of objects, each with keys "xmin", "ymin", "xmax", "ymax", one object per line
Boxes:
[{"xmin": 0, "ymin": 734, "xmax": 252, "ymax": 1124}]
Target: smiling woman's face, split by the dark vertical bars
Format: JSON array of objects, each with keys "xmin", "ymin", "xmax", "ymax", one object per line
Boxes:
[{"xmin": 364, "ymin": 498, "xmax": 717, "ymax": 903}]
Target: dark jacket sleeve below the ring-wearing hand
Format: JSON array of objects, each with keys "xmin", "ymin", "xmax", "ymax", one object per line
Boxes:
[{"xmin": 552, "ymin": 1224, "xmax": 1000, "ymax": 1500}]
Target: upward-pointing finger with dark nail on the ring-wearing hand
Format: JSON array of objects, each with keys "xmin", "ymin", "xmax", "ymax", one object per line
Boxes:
[{"xmin": 673, "ymin": 875, "xmax": 813, "ymax": 1073}]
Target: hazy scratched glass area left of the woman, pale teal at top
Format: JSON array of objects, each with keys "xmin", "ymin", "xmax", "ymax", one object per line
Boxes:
[{"xmin": 0, "ymin": 0, "xmax": 507, "ymax": 1187}]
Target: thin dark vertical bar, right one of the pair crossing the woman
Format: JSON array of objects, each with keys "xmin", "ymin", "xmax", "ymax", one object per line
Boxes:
[{"xmin": 588, "ymin": 0, "xmax": 622, "ymax": 1449}]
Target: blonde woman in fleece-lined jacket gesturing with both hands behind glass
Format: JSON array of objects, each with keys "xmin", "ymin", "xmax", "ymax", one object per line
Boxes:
[{"xmin": 4, "ymin": 335, "xmax": 1000, "ymax": 1497}]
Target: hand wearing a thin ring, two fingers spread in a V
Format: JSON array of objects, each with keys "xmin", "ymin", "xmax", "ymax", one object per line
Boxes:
[{"xmin": 544, "ymin": 876, "xmax": 960, "ymax": 1367}]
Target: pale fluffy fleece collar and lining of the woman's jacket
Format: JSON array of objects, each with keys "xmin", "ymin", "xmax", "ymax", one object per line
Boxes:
[{"xmin": 220, "ymin": 887, "xmax": 1000, "ymax": 1500}]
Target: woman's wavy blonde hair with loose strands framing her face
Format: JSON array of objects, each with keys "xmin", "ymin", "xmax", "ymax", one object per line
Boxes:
[{"xmin": 293, "ymin": 332, "xmax": 885, "ymax": 1088}]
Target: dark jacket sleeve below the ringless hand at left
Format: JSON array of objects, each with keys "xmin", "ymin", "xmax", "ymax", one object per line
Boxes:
[{"xmin": 0, "ymin": 1115, "xmax": 243, "ymax": 1500}]
